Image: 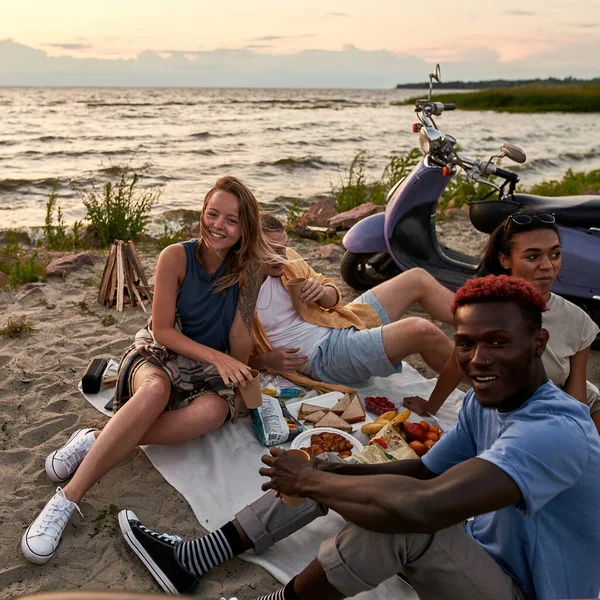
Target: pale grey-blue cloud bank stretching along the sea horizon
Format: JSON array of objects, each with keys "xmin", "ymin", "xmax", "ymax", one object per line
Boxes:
[{"xmin": 0, "ymin": 39, "xmax": 600, "ymax": 88}]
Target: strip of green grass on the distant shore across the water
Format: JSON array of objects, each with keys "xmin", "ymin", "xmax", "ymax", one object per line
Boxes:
[{"xmin": 404, "ymin": 83, "xmax": 600, "ymax": 113}]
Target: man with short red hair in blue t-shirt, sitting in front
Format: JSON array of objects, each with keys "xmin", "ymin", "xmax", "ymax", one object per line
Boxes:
[{"xmin": 119, "ymin": 276, "xmax": 600, "ymax": 600}]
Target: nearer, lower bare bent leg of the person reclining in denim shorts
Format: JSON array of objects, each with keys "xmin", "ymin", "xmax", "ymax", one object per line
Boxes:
[{"xmin": 382, "ymin": 317, "xmax": 454, "ymax": 373}]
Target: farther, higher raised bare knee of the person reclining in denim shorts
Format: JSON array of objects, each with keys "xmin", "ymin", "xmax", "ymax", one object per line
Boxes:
[{"xmin": 371, "ymin": 269, "xmax": 454, "ymax": 325}]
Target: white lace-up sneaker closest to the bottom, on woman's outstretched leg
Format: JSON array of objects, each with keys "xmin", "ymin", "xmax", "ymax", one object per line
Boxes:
[{"xmin": 21, "ymin": 487, "xmax": 83, "ymax": 565}]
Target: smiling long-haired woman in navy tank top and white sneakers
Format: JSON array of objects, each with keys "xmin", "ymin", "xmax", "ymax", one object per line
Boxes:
[{"xmin": 21, "ymin": 177, "xmax": 276, "ymax": 564}]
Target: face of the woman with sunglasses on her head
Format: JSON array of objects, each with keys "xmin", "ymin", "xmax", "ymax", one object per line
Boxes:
[{"xmin": 500, "ymin": 229, "xmax": 562, "ymax": 299}]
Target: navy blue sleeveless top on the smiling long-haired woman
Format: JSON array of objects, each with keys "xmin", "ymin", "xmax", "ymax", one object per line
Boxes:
[{"xmin": 177, "ymin": 240, "xmax": 240, "ymax": 352}]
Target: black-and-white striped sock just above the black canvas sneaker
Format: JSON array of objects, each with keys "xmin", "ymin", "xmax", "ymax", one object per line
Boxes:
[{"xmin": 175, "ymin": 522, "xmax": 245, "ymax": 577}]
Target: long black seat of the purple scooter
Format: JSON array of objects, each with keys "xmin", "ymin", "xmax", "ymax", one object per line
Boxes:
[{"xmin": 469, "ymin": 194, "xmax": 600, "ymax": 233}]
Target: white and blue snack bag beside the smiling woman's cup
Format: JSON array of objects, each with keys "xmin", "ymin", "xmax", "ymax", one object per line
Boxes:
[{"xmin": 250, "ymin": 394, "xmax": 305, "ymax": 446}]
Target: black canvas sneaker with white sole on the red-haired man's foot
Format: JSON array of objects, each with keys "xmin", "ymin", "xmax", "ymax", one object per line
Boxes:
[{"xmin": 119, "ymin": 510, "xmax": 199, "ymax": 594}]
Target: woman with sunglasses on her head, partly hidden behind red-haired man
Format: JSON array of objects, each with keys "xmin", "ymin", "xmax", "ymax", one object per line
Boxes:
[{"xmin": 404, "ymin": 213, "xmax": 600, "ymax": 432}]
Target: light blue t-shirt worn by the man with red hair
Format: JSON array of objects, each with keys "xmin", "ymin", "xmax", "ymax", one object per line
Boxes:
[{"xmin": 423, "ymin": 381, "xmax": 600, "ymax": 600}]
